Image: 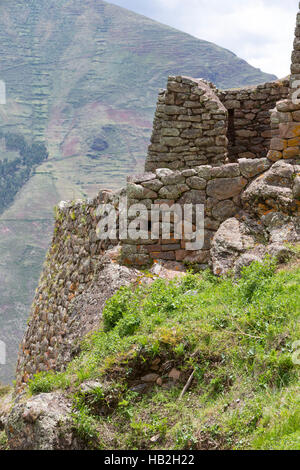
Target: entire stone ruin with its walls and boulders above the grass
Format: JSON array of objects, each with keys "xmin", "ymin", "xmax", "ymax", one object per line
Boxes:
[{"xmin": 17, "ymin": 4, "xmax": 300, "ymax": 390}]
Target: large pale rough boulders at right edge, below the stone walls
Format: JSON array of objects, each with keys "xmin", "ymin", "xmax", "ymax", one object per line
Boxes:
[{"xmin": 211, "ymin": 160, "xmax": 300, "ymax": 275}]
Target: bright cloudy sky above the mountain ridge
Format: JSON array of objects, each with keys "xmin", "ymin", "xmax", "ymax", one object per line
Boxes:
[{"xmin": 107, "ymin": 0, "xmax": 299, "ymax": 78}]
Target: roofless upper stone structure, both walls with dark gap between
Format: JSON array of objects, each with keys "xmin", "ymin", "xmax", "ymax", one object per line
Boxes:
[{"xmin": 145, "ymin": 77, "xmax": 289, "ymax": 171}]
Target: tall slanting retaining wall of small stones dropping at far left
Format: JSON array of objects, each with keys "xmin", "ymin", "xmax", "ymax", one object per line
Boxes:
[{"xmin": 17, "ymin": 191, "xmax": 119, "ymax": 385}]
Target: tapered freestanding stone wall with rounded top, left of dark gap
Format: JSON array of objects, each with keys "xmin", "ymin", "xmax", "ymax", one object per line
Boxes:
[{"xmin": 145, "ymin": 77, "xmax": 227, "ymax": 171}]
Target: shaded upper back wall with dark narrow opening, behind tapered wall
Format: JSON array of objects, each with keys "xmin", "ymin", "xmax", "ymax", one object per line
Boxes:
[{"xmin": 218, "ymin": 79, "xmax": 289, "ymax": 162}]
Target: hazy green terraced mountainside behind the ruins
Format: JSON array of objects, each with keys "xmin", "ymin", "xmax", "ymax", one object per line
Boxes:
[{"xmin": 0, "ymin": 0, "xmax": 275, "ymax": 382}]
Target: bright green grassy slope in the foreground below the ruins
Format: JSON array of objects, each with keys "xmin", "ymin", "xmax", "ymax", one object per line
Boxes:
[{"xmin": 29, "ymin": 259, "xmax": 300, "ymax": 449}]
